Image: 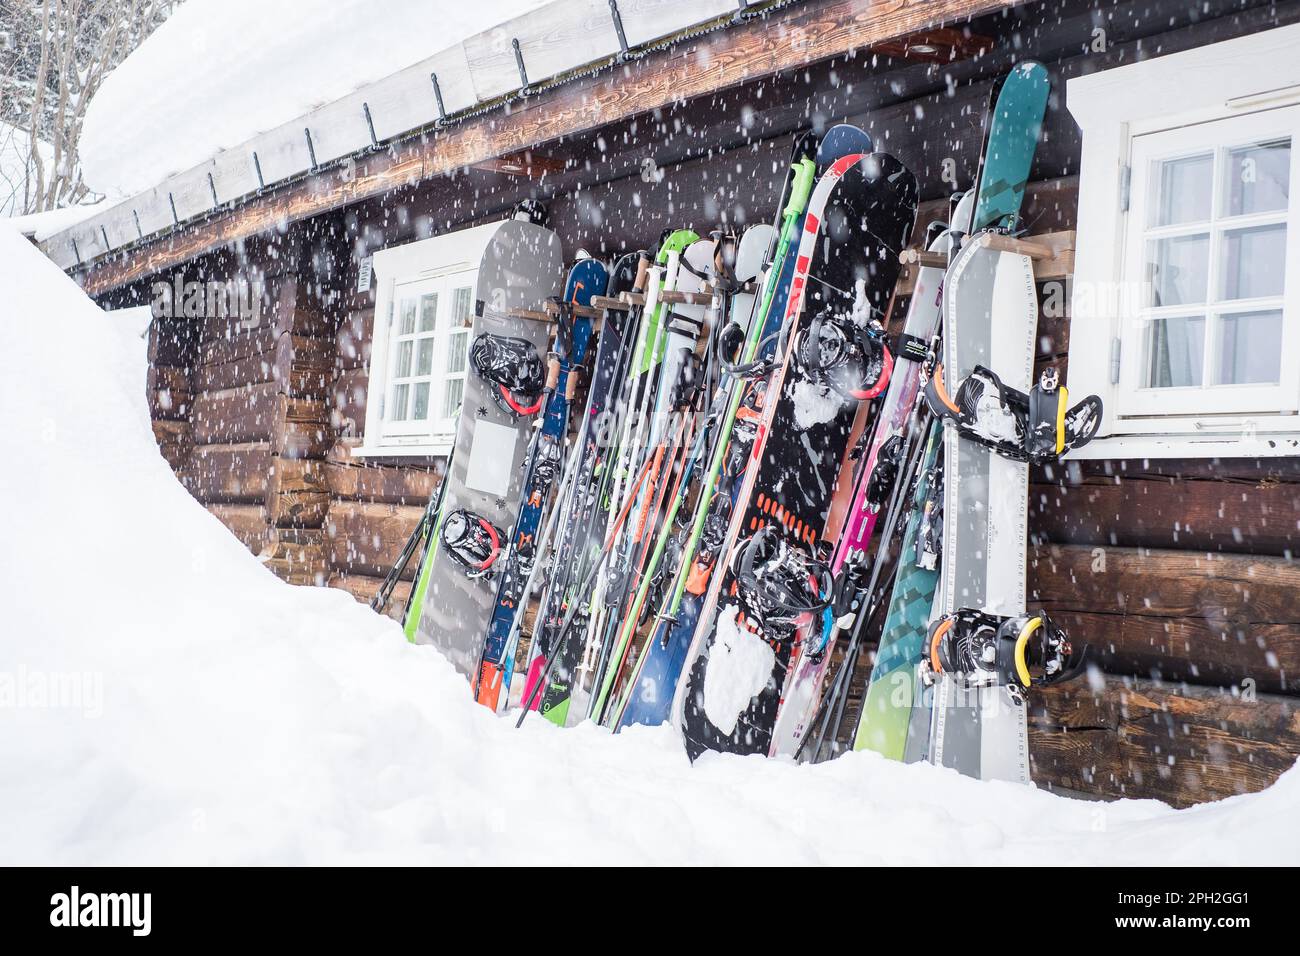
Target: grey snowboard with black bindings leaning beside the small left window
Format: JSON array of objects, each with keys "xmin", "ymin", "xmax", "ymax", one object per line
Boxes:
[{"xmin": 406, "ymin": 220, "xmax": 564, "ymax": 680}]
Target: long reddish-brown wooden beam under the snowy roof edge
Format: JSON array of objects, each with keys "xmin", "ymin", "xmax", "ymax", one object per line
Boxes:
[{"xmin": 71, "ymin": 0, "xmax": 1023, "ymax": 295}]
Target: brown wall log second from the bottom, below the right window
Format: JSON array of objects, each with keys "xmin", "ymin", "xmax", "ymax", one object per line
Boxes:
[{"xmin": 1028, "ymin": 545, "xmax": 1300, "ymax": 695}]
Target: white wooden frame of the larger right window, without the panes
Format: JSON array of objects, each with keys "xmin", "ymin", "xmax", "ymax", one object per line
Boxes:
[{"xmin": 1067, "ymin": 26, "xmax": 1300, "ymax": 458}]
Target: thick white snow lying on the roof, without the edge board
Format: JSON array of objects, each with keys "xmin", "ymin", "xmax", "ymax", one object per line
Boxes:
[{"xmin": 79, "ymin": 0, "xmax": 546, "ymax": 199}]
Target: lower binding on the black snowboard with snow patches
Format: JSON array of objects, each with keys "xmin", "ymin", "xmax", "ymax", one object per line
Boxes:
[{"xmin": 736, "ymin": 525, "xmax": 835, "ymax": 639}]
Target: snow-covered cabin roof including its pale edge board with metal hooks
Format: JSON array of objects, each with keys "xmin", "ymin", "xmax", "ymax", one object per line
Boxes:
[{"xmin": 42, "ymin": 0, "xmax": 743, "ymax": 277}]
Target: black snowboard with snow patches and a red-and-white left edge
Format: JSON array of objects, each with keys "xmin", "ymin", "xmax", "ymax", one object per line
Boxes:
[{"xmin": 679, "ymin": 153, "xmax": 918, "ymax": 760}]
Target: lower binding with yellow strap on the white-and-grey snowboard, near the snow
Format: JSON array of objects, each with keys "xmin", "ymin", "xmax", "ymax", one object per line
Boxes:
[{"xmin": 927, "ymin": 607, "xmax": 1089, "ymax": 693}]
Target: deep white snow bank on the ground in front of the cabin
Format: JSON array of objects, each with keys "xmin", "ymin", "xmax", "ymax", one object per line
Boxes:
[{"xmin": 0, "ymin": 222, "xmax": 1300, "ymax": 865}]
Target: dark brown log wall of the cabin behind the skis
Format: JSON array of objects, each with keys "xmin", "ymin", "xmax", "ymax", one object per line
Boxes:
[{"xmin": 101, "ymin": 0, "xmax": 1300, "ymax": 805}]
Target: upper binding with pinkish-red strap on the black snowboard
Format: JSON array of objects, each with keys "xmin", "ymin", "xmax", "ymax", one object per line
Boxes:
[{"xmin": 798, "ymin": 311, "xmax": 893, "ymax": 402}]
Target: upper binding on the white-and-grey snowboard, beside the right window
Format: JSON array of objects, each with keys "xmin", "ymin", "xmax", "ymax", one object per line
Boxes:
[{"xmin": 926, "ymin": 364, "xmax": 1101, "ymax": 464}]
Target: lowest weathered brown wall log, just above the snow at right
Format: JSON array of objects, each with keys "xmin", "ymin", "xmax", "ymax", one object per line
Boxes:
[{"xmin": 1030, "ymin": 678, "xmax": 1300, "ymax": 806}]
